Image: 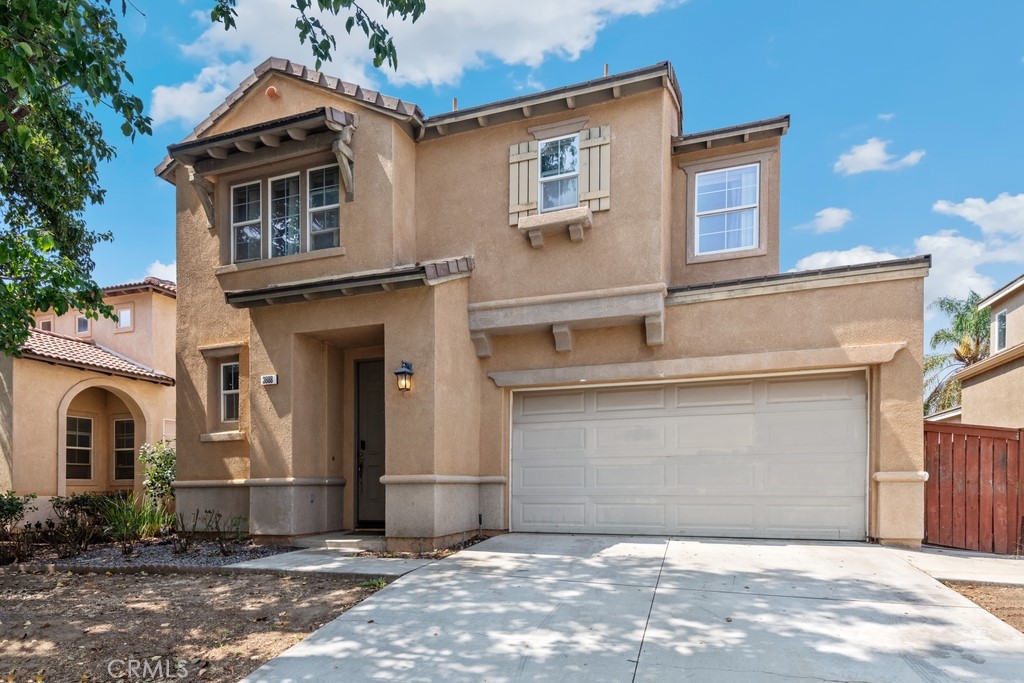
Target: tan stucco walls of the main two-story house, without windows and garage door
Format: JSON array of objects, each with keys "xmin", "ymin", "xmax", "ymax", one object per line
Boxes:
[{"xmin": 158, "ymin": 60, "xmax": 928, "ymax": 548}]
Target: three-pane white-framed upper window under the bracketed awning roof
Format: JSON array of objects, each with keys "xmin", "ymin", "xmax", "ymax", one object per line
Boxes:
[{"xmin": 230, "ymin": 165, "xmax": 341, "ymax": 263}]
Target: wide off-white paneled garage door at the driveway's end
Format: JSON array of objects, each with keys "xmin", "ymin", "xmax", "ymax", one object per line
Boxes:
[{"xmin": 511, "ymin": 373, "xmax": 867, "ymax": 540}]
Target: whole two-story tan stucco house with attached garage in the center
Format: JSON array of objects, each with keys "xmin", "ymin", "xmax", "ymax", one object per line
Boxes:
[{"xmin": 157, "ymin": 59, "xmax": 930, "ymax": 549}]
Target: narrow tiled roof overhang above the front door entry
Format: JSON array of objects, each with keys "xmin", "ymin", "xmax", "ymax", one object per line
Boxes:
[{"xmin": 224, "ymin": 256, "xmax": 474, "ymax": 308}]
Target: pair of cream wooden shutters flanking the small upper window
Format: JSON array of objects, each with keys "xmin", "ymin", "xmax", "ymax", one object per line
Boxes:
[{"xmin": 509, "ymin": 125, "xmax": 611, "ymax": 225}]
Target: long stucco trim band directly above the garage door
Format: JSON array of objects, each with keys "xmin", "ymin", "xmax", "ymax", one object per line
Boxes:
[{"xmin": 487, "ymin": 342, "xmax": 906, "ymax": 387}]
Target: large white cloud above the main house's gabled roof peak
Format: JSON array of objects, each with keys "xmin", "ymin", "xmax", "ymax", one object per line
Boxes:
[{"xmin": 154, "ymin": 0, "xmax": 680, "ymax": 123}]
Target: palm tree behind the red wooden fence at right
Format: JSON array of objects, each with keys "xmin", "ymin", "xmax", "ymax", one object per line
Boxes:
[{"xmin": 925, "ymin": 290, "xmax": 989, "ymax": 415}]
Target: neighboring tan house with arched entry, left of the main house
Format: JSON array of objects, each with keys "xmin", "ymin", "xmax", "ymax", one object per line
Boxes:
[{"xmin": 0, "ymin": 278, "xmax": 176, "ymax": 509}]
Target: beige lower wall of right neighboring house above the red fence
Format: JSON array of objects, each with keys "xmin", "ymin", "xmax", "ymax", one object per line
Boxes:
[{"xmin": 961, "ymin": 356, "xmax": 1024, "ymax": 428}]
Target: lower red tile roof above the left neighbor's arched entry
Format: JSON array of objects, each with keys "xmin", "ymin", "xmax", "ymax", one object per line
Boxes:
[{"xmin": 20, "ymin": 330, "xmax": 174, "ymax": 385}]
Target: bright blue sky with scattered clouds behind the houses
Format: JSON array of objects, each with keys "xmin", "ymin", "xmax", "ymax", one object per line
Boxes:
[{"xmin": 86, "ymin": 0, "xmax": 1024, "ymax": 339}]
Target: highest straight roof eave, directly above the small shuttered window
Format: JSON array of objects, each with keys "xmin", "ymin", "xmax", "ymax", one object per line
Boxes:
[{"xmin": 417, "ymin": 61, "xmax": 683, "ymax": 141}]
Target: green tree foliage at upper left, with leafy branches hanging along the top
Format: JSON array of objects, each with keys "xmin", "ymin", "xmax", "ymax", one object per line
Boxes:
[{"xmin": 0, "ymin": 0, "xmax": 426, "ymax": 354}]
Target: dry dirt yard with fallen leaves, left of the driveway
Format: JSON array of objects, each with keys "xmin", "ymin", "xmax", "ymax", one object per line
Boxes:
[{"xmin": 0, "ymin": 567, "xmax": 383, "ymax": 683}]
